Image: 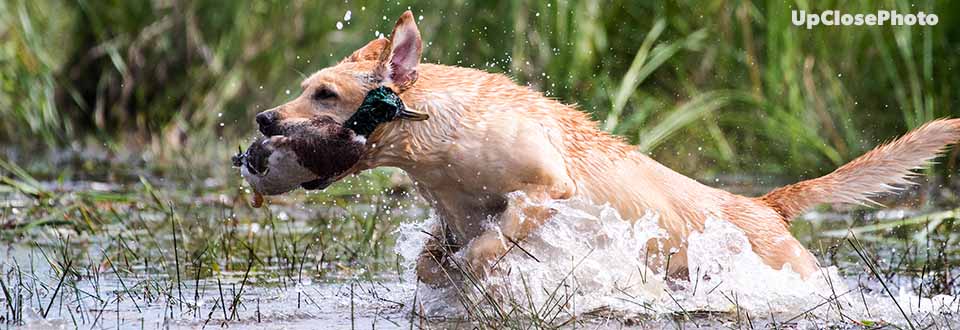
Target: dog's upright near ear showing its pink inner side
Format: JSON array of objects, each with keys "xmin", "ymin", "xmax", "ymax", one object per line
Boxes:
[{"xmin": 377, "ymin": 10, "xmax": 423, "ymax": 91}]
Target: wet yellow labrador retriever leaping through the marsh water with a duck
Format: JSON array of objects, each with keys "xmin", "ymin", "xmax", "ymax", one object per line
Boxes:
[{"xmin": 257, "ymin": 11, "xmax": 960, "ymax": 284}]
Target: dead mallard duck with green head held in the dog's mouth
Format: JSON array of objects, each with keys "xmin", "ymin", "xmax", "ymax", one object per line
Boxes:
[{"xmin": 232, "ymin": 86, "xmax": 429, "ymax": 207}]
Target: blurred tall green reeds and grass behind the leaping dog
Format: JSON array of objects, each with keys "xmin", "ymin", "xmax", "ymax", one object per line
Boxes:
[{"xmin": 0, "ymin": 0, "xmax": 960, "ymax": 179}]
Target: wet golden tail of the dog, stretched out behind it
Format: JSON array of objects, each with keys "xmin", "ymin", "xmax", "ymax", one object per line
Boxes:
[{"xmin": 759, "ymin": 119, "xmax": 960, "ymax": 223}]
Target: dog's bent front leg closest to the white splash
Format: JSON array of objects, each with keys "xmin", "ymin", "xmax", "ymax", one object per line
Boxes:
[{"xmin": 466, "ymin": 185, "xmax": 572, "ymax": 278}]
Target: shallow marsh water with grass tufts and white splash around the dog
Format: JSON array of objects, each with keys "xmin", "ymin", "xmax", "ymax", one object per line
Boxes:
[{"xmin": 0, "ymin": 163, "xmax": 960, "ymax": 329}]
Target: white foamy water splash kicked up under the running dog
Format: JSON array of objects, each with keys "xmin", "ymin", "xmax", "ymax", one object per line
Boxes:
[{"xmin": 397, "ymin": 195, "xmax": 960, "ymax": 326}]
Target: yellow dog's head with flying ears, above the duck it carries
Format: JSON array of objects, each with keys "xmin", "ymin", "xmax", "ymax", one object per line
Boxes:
[{"xmin": 256, "ymin": 11, "xmax": 423, "ymax": 136}]
